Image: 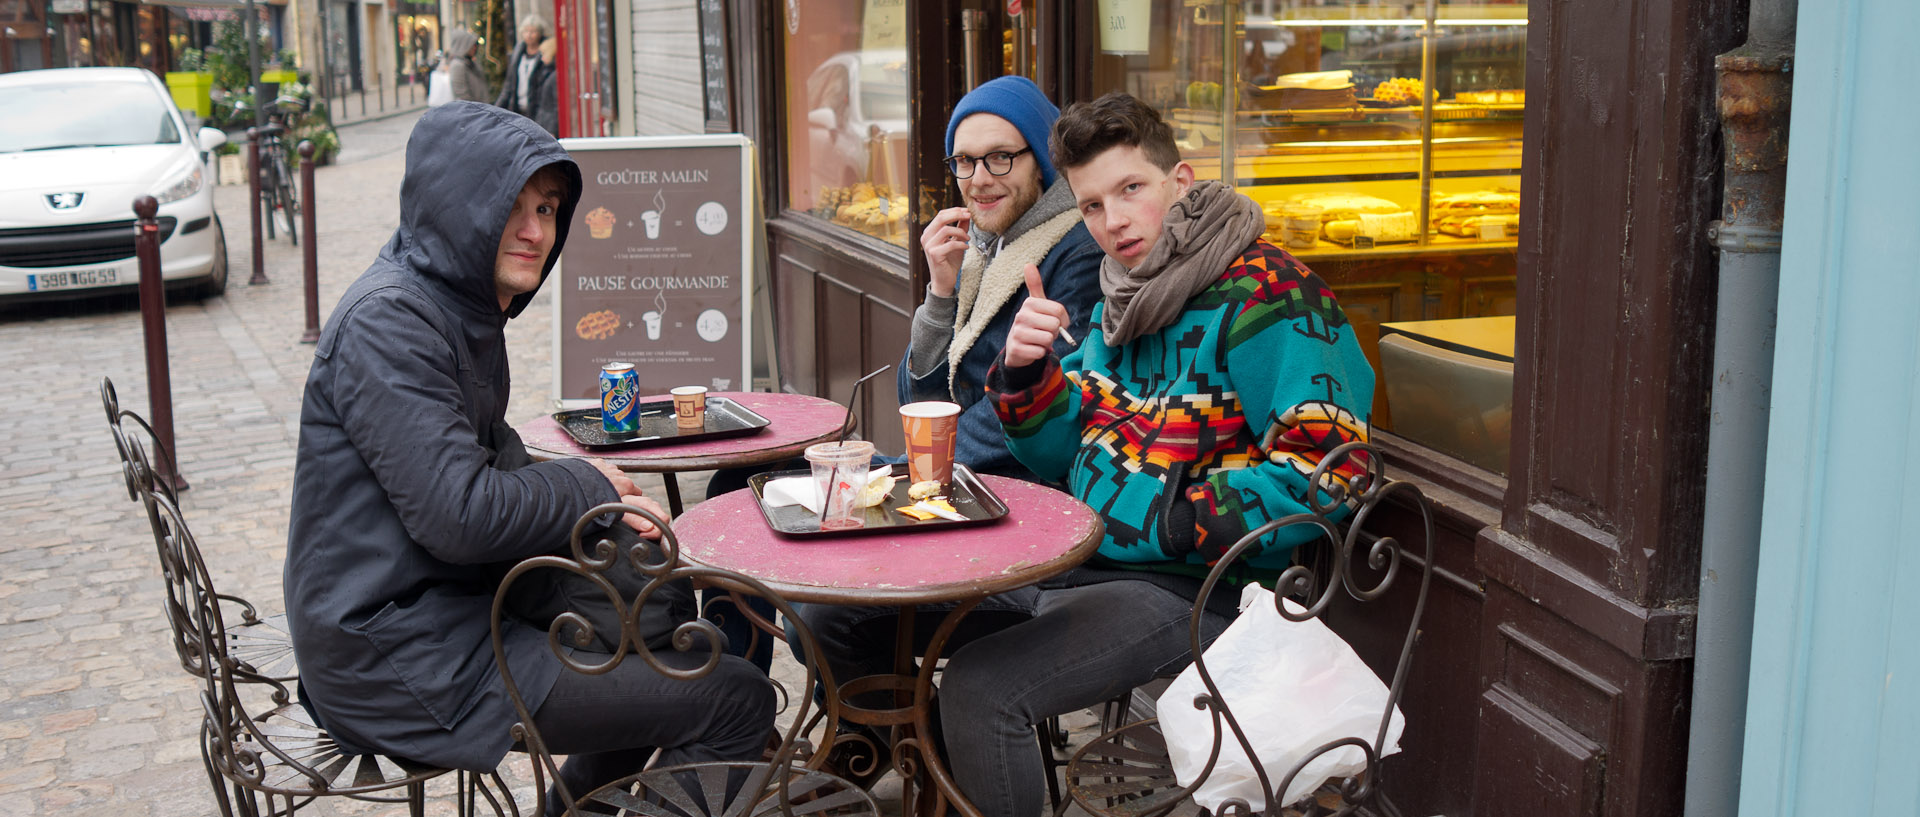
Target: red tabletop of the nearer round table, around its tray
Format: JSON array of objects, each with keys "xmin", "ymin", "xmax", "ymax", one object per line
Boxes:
[{"xmin": 674, "ymin": 474, "xmax": 1104, "ymax": 604}]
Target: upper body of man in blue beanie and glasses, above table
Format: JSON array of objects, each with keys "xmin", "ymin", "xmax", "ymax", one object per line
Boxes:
[{"xmin": 899, "ymin": 77, "xmax": 1100, "ymax": 479}]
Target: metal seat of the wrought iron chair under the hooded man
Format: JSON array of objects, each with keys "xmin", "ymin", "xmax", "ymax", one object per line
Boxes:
[{"xmin": 215, "ymin": 704, "xmax": 449, "ymax": 796}]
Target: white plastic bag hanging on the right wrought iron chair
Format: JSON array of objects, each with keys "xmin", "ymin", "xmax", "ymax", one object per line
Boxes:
[{"xmin": 1158, "ymin": 585, "xmax": 1405, "ymax": 813}]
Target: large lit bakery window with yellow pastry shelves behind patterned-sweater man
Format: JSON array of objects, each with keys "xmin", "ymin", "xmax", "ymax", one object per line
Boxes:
[{"xmin": 1092, "ymin": 0, "xmax": 1526, "ymax": 472}]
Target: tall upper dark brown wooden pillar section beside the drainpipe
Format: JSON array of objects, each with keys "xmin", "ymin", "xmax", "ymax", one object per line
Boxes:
[{"xmin": 1503, "ymin": 0, "xmax": 1745, "ymax": 606}]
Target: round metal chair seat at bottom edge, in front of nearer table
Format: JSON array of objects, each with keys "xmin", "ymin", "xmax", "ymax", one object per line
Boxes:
[{"xmin": 576, "ymin": 763, "xmax": 879, "ymax": 817}]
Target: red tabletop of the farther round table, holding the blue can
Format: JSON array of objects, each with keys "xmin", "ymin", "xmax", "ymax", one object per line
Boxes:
[{"xmin": 515, "ymin": 391, "xmax": 847, "ymax": 474}]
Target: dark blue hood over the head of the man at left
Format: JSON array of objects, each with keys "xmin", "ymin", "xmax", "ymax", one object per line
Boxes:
[{"xmin": 380, "ymin": 102, "xmax": 582, "ymax": 318}]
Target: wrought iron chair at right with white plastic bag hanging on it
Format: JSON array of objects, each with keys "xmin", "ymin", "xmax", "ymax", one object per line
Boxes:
[{"xmin": 1056, "ymin": 443, "xmax": 1434, "ymax": 817}]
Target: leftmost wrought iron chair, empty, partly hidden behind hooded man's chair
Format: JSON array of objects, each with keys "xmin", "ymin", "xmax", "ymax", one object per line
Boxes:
[{"xmin": 100, "ymin": 378, "xmax": 300, "ymax": 682}]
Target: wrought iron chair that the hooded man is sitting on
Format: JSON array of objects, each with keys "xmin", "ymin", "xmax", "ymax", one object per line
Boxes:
[{"xmin": 129, "ymin": 452, "xmax": 507, "ymax": 817}]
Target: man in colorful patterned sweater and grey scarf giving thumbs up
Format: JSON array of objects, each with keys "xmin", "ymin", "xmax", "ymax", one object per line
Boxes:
[{"xmin": 941, "ymin": 94, "xmax": 1373, "ymax": 817}]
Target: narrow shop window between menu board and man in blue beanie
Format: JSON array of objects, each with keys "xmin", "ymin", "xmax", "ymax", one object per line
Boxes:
[{"xmin": 781, "ymin": 0, "xmax": 910, "ymax": 247}]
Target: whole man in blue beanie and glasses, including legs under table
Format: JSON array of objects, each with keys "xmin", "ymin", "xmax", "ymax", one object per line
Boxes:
[{"xmin": 801, "ymin": 77, "xmax": 1102, "ymax": 782}]
